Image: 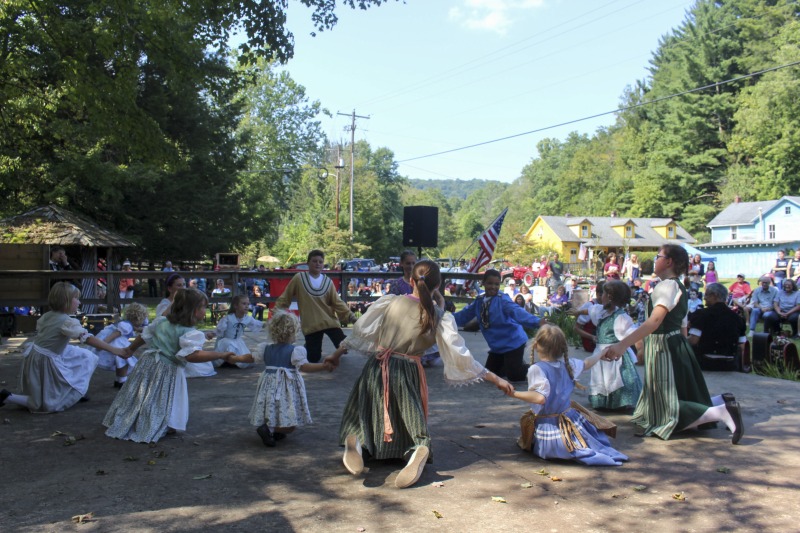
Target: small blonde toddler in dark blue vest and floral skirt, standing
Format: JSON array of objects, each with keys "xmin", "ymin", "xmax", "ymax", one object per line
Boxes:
[{"xmin": 228, "ymin": 311, "xmax": 333, "ymax": 447}]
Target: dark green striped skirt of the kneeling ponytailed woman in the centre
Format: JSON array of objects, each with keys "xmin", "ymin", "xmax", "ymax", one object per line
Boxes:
[{"xmin": 339, "ymin": 355, "xmax": 432, "ymax": 462}]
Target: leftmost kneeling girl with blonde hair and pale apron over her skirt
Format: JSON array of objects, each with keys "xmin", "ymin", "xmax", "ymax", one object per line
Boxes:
[{"xmin": 0, "ymin": 281, "xmax": 126, "ymax": 413}]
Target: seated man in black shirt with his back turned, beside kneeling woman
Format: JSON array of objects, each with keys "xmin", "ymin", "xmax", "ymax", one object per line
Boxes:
[{"xmin": 689, "ymin": 283, "xmax": 747, "ymax": 370}]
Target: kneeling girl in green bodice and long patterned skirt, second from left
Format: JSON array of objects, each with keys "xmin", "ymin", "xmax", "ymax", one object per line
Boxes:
[{"xmin": 103, "ymin": 289, "xmax": 234, "ymax": 442}]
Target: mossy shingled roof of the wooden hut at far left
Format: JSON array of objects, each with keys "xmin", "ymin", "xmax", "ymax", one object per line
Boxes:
[{"xmin": 0, "ymin": 205, "xmax": 136, "ymax": 248}]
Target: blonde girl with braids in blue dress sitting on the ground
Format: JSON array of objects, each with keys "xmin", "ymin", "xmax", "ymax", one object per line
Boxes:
[{"xmin": 510, "ymin": 324, "xmax": 628, "ymax": 466}]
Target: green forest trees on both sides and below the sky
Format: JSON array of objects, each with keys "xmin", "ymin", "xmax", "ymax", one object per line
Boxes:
[{"xmin": 0, "ymin": 0, "xmax": 800, "ymax": 262}]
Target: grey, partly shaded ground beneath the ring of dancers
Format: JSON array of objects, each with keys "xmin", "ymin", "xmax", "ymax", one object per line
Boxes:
[{"xmin": 0, "ymin": 333, "xmax": 800, "ymax": 532}]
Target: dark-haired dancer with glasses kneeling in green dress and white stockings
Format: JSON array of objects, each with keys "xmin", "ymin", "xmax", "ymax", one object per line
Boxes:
[{"xmin": 603, "ymin": 244, "xmax": 744, "ymax": 444}]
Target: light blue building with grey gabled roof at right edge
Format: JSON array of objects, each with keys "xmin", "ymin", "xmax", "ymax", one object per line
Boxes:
[{"xmin": 695, "ymin": 196, "xmax": 800, "ymax": 278}]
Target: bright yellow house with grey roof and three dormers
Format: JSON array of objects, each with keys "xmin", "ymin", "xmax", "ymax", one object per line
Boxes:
[{"xmin": 525, "ymin": 216, "xmax": 697, "ymax": 263}]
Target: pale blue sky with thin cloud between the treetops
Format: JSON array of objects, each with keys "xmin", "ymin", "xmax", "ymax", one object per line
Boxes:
[{"xmin": 278, "ymin": 0, "xmax": 693, "ymax": 182}]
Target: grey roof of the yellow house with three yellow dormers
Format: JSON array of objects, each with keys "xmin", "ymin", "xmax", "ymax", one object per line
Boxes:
[{"xmin": 528, "ymin": 216, "xmax": 697, "ymax": 248}]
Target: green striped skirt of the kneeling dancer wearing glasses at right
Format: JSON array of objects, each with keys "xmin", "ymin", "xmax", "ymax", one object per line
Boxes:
[{"xmin": 632, "ymin": 331, "xmax": 715, "ymax": 440}]
